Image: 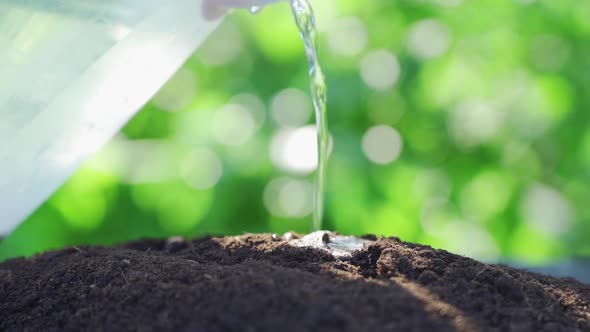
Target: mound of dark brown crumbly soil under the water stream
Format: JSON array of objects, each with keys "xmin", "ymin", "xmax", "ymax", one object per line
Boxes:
[{"xmin": 0, "ymin": 235, "xmax": 590, "ymax": 332}]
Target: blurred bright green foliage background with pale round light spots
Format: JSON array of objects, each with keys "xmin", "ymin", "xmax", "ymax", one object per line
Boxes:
[{"xmin": 0, "ymin": 0, "xmax": 590, "ymax": 264}]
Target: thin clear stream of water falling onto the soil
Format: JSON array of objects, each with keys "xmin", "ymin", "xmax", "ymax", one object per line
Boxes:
[{"xmin": 291, "ymin": 0, "xmax": 330, "ymax": 230}]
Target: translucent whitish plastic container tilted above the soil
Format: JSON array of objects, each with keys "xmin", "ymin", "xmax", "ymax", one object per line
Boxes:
[{"xmin": 0, "ymin": 0, "xmax": 280, "ymax": 236}]
